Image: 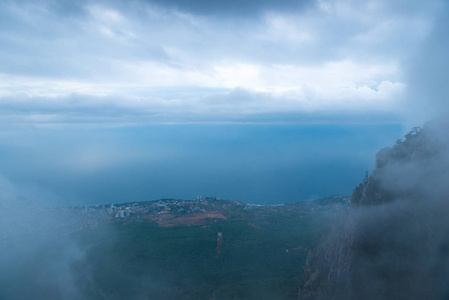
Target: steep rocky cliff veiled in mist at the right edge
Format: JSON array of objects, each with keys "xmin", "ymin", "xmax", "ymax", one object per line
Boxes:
[{"xmin": 299, "ymin": 123, "xmax": 449, "ymax": 299}]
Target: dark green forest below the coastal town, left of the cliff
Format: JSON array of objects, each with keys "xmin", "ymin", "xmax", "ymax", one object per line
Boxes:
[{"xmin": 73, "ymin": 204, "xmax": 337, "ymax": 299}]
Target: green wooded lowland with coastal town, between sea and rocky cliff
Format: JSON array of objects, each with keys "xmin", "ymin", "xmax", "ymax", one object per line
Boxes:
[{"xmin": 0, "ymin": 195, "xmax": 349, "ymax": 300}]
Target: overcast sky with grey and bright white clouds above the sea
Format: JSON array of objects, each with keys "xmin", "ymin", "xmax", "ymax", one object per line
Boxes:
[{"xmin": 0, "ymin": 0, "xmax": 447, "ymax": 124}]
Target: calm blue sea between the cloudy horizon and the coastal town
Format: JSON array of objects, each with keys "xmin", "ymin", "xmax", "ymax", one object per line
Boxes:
[{"xmin": 0, "ymin": 124, "xmax": 404, "ymax": 205}]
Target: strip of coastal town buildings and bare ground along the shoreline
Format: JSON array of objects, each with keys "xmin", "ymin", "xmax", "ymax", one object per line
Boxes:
[{"xmin": 55, "ymin": 195, "xmax": 349, "ymax": 230}]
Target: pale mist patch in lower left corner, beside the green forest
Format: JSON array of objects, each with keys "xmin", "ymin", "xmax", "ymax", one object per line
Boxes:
[{"xmin": 0, "ymin": 178, "xmax": 83, "ymax": 299}]
